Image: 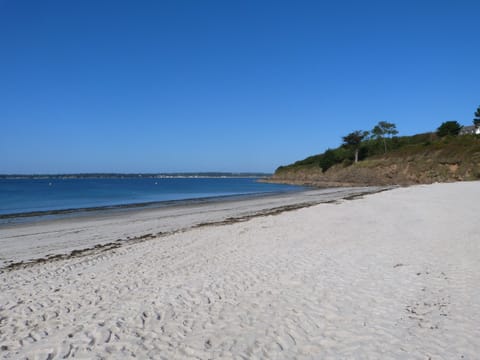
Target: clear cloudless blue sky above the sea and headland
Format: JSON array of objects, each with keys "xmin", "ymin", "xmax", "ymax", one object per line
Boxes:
[{"xmin": 0, "ymin": 0, "xmax": 480, "ymax": 173}]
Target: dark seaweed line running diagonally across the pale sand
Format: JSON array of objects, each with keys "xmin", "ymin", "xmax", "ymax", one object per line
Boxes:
[{"xmin": 0, "ymin": 188, "xmax": 391, "ymax": 274}]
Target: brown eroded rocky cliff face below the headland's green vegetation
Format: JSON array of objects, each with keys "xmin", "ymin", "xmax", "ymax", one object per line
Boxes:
[{"xmin": 270, "ymin": 147, "xmax": 480, "ymax": 187}]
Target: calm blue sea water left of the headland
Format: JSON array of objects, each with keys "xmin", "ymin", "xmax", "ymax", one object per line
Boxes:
[{"xmin": 0, "ymin": 178, "xmax": 299, "ymax": 215}]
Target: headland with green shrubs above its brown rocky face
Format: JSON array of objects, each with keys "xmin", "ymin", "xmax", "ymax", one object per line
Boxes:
[{"xmin": 272, "ymin": 133, "xmax": 480, "ymax": 186}]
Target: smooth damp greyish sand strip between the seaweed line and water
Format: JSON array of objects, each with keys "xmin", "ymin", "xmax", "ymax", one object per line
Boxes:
[{"xmin": 0, "ymin": 187, "xmax": 385, "ymax": 268}]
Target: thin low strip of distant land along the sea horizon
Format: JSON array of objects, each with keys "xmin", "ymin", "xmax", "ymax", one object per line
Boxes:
[{"xmin": 0, "ymin": 172, "xmax": 272, "ymax": 179}]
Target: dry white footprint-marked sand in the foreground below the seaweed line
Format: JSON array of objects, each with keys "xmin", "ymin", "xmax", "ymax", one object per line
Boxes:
[{"xmin": 0, "ymin": 182, "xmax": 480, "ymax": 359}]
